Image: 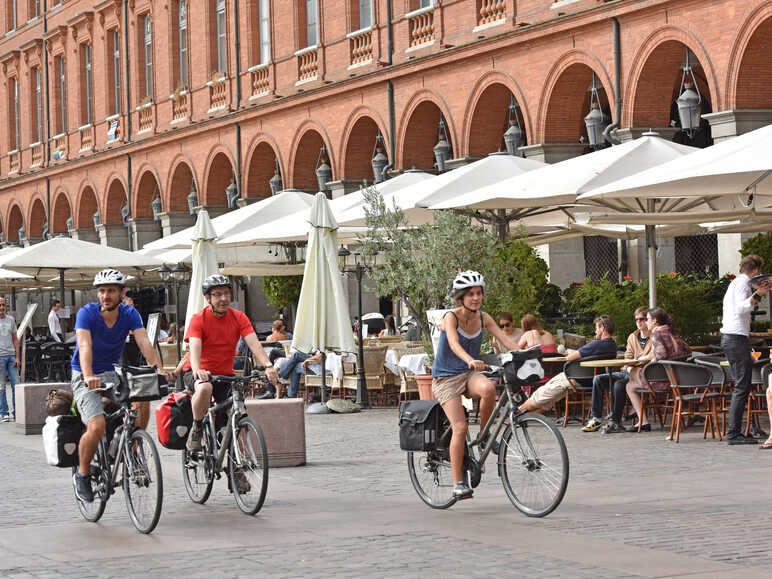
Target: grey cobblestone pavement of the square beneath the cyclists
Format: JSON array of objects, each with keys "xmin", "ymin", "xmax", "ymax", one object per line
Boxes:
[{"xmin": 0, "ymin": 410, "xmax": 772, "ymax": 577}]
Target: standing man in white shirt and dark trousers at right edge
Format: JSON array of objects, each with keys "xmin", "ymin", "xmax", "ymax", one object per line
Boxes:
[{"xmin": 721, "ymin": 254, "xmax": 770, "ymax": 445}]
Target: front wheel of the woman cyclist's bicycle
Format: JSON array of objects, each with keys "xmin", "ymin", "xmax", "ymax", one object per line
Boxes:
[{"xmin": 499, "ymin": 413, "xmax": 568, "ymax": 517}]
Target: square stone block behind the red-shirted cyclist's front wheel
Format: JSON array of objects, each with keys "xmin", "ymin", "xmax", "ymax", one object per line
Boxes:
[{"xmin": 246, "ymin": 398, "xmax": 306, "ymax": 467}]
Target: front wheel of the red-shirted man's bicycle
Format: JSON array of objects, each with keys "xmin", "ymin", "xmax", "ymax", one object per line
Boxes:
[{"xmin": 228, "ymin": 417, "xmax": 268, "ymax": 515}]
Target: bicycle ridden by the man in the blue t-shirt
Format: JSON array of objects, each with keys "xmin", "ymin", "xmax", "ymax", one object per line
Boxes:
[{"xmin": 72, "ymin": 378, "xmax": 163, "ymax": 534}]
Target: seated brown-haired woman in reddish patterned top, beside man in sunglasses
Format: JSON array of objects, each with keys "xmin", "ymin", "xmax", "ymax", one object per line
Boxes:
[{"xmin": 625, "ymin": 308, "xmax": 692, "ymax": 432}]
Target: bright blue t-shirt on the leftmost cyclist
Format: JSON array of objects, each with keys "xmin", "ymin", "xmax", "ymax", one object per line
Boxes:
[{"xmin": 70, "ymin": 302, "xmax": 143, "ymax": 374}]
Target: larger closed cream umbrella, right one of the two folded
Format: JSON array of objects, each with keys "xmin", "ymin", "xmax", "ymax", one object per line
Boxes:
[{"xmin": 292, "ymin": 193, "xmax": 361, "ymax": 412}]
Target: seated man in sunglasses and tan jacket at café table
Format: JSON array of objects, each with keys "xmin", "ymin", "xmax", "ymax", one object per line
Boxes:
[{"xmin": 582, "ymin": 306, "xmax": 651, "ymax": 434}]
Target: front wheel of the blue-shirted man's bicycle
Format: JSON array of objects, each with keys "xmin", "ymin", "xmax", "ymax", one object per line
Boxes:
[{"xmin": 122, "ymin": 429, "xmax": 164, "ymax": 533}]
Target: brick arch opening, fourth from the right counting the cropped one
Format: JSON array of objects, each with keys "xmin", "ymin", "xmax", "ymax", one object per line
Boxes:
[{"xmin": 469, "ymin": 83, "xmax": 528, "ymax": 157}]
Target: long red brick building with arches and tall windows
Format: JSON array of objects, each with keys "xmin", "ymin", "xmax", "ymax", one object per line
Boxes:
[{"xmin": 0, "ymin": 0, "xmax": 772, "ymax": 300}]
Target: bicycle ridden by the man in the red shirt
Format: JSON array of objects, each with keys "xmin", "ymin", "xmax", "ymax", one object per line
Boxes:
[{"xmin": 182, "ymin": 375, "xmax": 268, "ymax": 515}]
